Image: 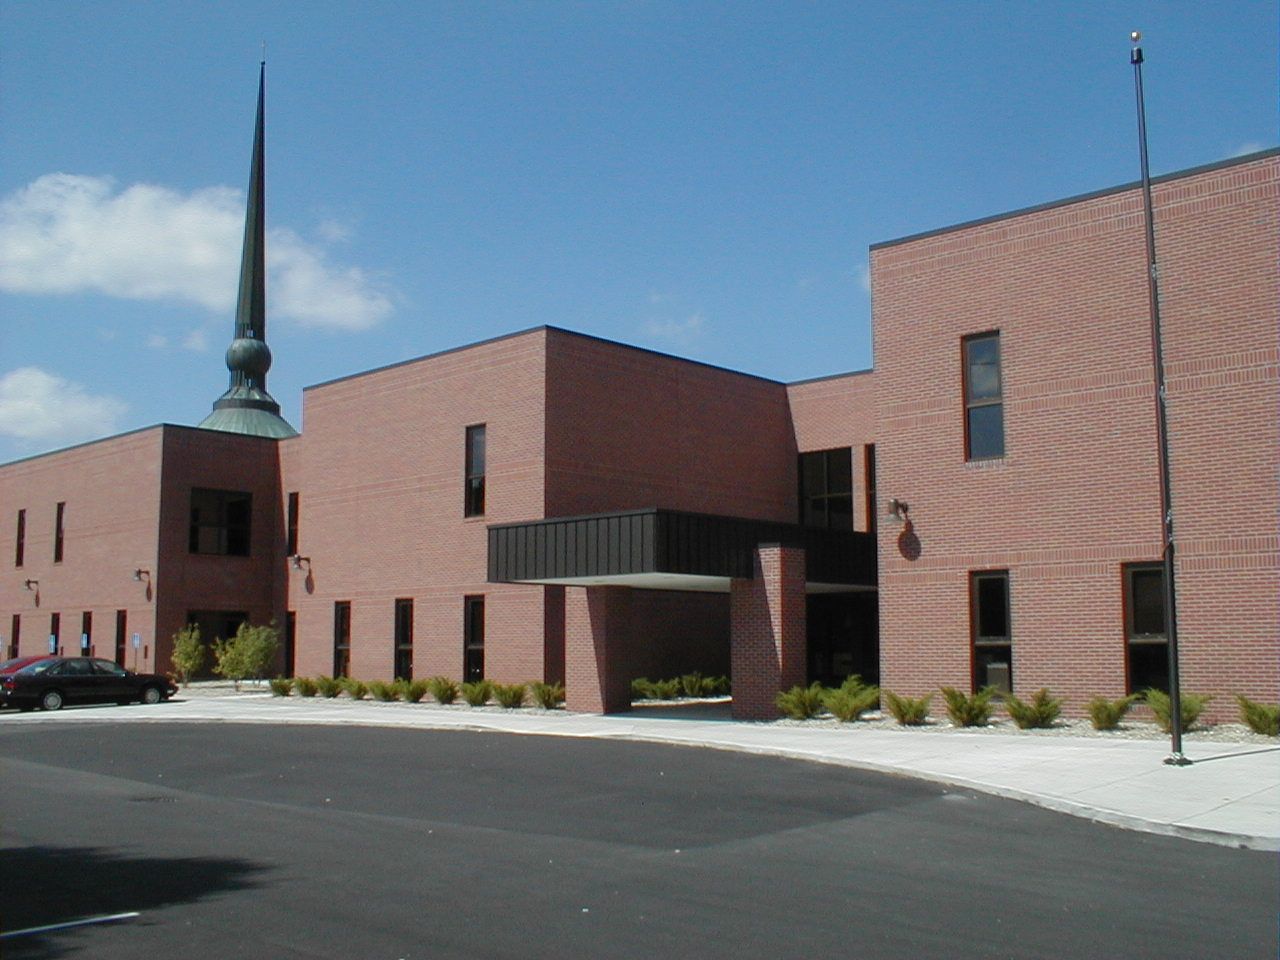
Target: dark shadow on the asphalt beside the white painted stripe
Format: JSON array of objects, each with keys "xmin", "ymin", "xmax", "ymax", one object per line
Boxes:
[{"xmin": 0, "ymin": 846, "xmax": 269, "ymax": 960}]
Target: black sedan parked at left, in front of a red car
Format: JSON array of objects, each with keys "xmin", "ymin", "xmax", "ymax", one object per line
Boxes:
[{"xmin": 0, "ymin": 657, "xmax": 178, "ymax": 710}]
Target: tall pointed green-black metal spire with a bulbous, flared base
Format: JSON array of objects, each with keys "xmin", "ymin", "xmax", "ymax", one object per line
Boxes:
[{"xmin": 200, "ymin": 60, "xmax": 298, "ymax": 438}]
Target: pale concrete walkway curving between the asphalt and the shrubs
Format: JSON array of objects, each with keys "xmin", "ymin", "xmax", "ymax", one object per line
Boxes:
[{"xmin": 0, "ymin": 686, "xmax": 1280, "ymax": 851}]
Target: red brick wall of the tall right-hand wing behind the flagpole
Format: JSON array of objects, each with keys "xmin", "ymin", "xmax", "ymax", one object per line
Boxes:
[{"xmin": 872, "ymin": 156, "xmax": 1280, "ymax": 719}]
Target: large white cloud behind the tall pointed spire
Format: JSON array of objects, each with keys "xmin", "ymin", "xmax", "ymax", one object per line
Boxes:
[{"xmin": 0, "ymin": 173, "xmax": 392, "ymax": 330}]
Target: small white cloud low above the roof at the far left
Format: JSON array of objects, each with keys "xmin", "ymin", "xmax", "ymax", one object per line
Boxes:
[{"xmin": 0, "ymin": 366, "xmax": 128, "ymax": 444}]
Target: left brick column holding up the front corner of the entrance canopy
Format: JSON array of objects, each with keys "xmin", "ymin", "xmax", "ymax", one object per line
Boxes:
[{"xmin": 564, "ymin": 586, "xmax": 634, "ymax": 713}]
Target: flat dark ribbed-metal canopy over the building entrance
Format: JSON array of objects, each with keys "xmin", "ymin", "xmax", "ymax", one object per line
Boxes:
[{"xmin": 489, "ymin": 507, "xmax": 876, "ymax": 593}]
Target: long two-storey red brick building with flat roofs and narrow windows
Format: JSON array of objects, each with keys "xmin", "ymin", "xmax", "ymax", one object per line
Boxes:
[{"xmin": 0, "ymin": 124, "xmax": 1280, "ymax": 717}]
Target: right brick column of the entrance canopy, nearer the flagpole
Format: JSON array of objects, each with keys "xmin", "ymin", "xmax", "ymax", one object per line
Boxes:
[{"xmin": 730, "ymin": 544, "xmax": 808, "ymax": 719}]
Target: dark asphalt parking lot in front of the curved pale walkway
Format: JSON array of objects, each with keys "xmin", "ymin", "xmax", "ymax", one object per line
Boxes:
[{"xmin": 0, "ymin": 722, "xmax": 1280, "ymax": 960}]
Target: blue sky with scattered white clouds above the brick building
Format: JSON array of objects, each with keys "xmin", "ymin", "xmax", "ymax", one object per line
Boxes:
[{"xmin": 0, "ymin": 0, "xmax": 1280, "ymax": 462}]
